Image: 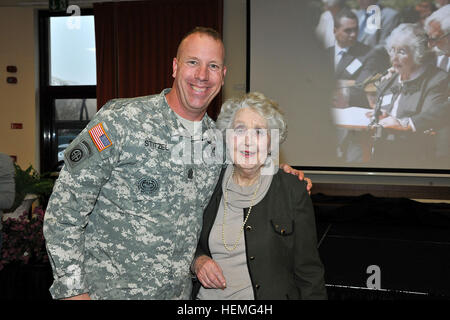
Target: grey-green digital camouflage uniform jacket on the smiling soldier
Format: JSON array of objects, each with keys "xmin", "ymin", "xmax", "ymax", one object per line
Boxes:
[{"xmin": 44, "ymin": 89, "xmax": 222, "ymax": 299}]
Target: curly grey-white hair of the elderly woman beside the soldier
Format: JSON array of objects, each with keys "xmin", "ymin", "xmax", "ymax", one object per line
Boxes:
[{"xmin": 216, "ymin": 92, "xmax": 287, "ymax": 144}]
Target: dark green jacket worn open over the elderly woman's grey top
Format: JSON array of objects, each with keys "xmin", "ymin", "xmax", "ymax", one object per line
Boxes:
[{"xmin": 192, "ymin": 170, "xmax": 327, "ymax": 300}]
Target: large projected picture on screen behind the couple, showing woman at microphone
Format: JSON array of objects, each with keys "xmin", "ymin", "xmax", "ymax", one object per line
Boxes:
[{"xmin": 249, "ymin": 0, "xmax": 450, "ymax": 172}]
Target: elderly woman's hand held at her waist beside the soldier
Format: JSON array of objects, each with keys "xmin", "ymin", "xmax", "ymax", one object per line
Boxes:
[{"xmin": 194, "ymin": 256, "xmax": 227, "ymax": 289}]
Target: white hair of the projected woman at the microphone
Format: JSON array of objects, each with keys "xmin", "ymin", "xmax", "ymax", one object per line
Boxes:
[{"xmin": 386, "ymin": 23, "xmax": 430, "ymax": 65}]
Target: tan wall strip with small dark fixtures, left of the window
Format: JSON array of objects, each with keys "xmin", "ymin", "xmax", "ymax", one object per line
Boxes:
[{"xmin": 0, "ymin": 7, "xmax": 39, "ymax": 169}]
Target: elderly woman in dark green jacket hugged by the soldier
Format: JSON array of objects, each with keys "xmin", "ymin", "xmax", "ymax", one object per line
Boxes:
[{"xmin": 192, "ymin": 92, "xmax": 327, "ymax": 300}]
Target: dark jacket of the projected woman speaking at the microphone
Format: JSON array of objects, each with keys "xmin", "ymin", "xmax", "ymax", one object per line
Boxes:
[{"xmin": 375, "ymin": 64, "xmax": 450, "ymax": 165}]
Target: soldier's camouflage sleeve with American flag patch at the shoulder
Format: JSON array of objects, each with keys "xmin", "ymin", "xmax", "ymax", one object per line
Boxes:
[{"xmin": 44, "ymin": 101, "xmax": 125, "ymax": 299}]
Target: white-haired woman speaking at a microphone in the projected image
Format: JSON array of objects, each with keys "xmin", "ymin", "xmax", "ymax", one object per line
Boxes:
[{"xmin": 375, "ymin": 23, "xmax": 449, "ymax": 167}]
